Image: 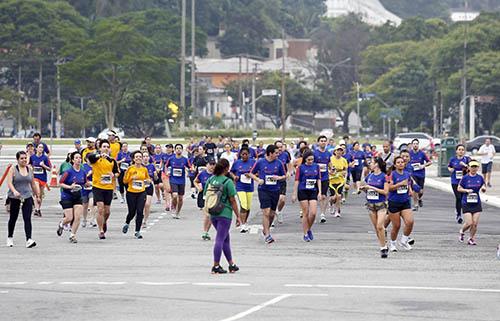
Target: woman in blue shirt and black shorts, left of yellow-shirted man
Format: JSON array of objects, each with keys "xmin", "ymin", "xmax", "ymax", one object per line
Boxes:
[{"xmin": 57, "ymin": 152, "xmax": 87, "ymax": 243}]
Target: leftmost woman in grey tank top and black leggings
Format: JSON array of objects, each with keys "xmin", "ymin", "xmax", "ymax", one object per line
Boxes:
[{"xmin": 7, "ymin": 151, "xmax": 40, "ymax": 248}]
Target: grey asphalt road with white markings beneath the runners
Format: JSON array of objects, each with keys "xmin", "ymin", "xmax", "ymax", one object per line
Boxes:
[{"xmin": 0, "ymin": 172, "xmax": 500, "ymax": 321}]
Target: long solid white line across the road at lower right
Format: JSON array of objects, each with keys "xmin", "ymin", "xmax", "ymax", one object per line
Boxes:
[{"xmin": 285, "ymin": 284, "xmax": 500, "ymax": 293}]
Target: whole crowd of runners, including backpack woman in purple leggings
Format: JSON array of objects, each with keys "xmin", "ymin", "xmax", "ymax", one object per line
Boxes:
[{"xmin": 2, "ymin": 131, "xmax": 489, "ymax": 273}]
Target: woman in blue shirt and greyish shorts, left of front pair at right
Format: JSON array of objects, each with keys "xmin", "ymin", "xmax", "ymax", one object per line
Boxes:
[{"xmin": 361, "ymin": 157, "xmax": 389, "ymax": 259}]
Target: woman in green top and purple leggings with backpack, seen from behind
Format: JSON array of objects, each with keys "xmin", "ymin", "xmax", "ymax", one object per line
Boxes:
[{"xmin": 203, "ymin": 158, "xmax": 241, "ymax": 274}]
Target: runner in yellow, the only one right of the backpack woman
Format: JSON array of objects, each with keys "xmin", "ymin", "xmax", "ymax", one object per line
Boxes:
[{"xmin": 328, "ymin": 145, "xmax": 349, "ymax": 217}]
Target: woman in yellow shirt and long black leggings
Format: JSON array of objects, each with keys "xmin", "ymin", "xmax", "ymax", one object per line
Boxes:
[{"xmin": 122, "ymin": 151, "xmax": 151, "ymax": 239}]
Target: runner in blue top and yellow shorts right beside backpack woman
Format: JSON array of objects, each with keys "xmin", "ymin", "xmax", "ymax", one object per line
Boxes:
[{"xmin": 231, "ymin": 146, "xmax": 256, "ymax": 233}]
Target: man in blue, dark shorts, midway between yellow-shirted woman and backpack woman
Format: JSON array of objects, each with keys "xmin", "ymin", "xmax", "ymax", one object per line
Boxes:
[{"xmin": 163, "ymin": 144, "xmax": 194, "ymax": 219}]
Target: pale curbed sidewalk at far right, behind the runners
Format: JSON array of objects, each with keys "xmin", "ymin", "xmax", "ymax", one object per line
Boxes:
[{"xmin": 425, "ymin": 164, "xmax": 500, "ymax": 208}]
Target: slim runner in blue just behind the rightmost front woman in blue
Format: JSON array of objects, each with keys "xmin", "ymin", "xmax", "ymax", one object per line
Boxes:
[{"xmin": 448, "ymin": 144, "xmax": 471, "ymax": 224}]
